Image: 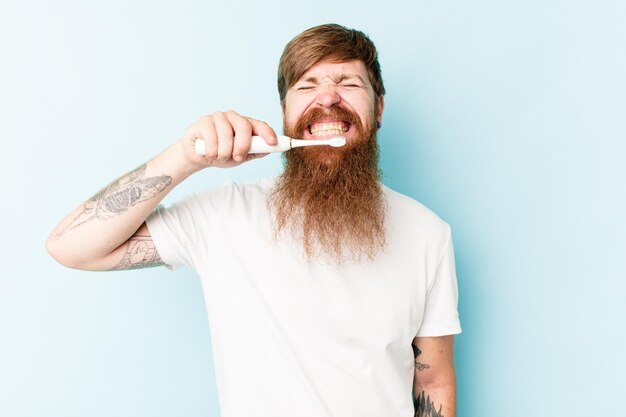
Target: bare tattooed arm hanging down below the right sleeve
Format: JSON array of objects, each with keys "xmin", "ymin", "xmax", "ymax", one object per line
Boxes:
[{"xmin": 413, "ymin": 335, "xmax": 456, "ymax": 417}]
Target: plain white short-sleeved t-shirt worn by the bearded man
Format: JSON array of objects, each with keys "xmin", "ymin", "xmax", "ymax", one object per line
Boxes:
[{"xmin": 147, "ymin": 180, "xmax": 461, "ymax": 417}]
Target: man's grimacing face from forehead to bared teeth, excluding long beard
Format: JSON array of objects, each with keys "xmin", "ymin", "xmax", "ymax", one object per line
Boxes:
[{"xmin": 283, "ymin": 57, "xmax": 384, "ymax": 145}]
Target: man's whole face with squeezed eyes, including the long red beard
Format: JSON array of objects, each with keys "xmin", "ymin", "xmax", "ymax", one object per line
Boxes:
[{"xmin": 270, "ymin": 61, "xmax": 385, "ymax": 263}]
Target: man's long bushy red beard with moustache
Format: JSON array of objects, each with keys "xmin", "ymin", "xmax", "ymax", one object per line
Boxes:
[{"xmin": 269, "ymin": 109, "xmax": 385, "ymax": 264}]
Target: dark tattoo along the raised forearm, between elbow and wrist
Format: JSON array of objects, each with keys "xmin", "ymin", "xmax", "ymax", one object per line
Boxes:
[{"xmin": 55, "ymin": 164, "xmax": 172, "ymax": 239}]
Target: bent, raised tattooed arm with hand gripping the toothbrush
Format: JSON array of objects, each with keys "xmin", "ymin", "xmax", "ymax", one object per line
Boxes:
[{"xmin": 46, "ymin": 111, "xmax": 276, "ymax": 270}]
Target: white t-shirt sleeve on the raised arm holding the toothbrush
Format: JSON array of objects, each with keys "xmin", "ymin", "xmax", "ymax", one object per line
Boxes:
[{"xmin": 146, "ymin": 197, "xmax": 201, "ymax": 269}]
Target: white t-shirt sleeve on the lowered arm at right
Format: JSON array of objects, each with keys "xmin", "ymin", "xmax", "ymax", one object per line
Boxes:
[{"xmin": 416, "ymin": 227, "xmax": 461, "ymax": 337}]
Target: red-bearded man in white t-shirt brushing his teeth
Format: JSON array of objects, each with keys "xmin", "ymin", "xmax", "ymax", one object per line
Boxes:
[{"xmin": 47, "ymin": 25, "xmax": 460, "ymax": 417}]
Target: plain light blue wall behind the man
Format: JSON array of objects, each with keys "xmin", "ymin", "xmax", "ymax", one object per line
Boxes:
[{"xmin": 0, "ymin": 0, "xmax": 626, "ymax": 417}]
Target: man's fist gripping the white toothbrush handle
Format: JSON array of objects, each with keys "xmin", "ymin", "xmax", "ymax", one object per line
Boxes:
[{"xmin": 180, "ymin": 110, "xmax": 278, "ymax": 170}]
